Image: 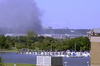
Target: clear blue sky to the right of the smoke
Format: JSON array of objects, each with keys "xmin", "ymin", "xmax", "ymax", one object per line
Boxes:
[{"xmin": 35, "ymin": 0, "xmax": 100, "ymax": 29}]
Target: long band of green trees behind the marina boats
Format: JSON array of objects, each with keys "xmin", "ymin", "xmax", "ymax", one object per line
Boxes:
[{"xmin": 0, "ymin": 31, "xmax": 90, "ymax": 51}]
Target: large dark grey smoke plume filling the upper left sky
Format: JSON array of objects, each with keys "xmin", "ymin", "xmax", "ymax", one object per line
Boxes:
[{"xmin": 0, "ymin": 0, "xmax": 42, "ymax": 33}]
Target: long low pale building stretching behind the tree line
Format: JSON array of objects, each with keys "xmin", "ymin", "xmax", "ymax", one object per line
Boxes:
[{"xmin": 5, "ymin": 34, "xmax": 87, "ymax": 39}]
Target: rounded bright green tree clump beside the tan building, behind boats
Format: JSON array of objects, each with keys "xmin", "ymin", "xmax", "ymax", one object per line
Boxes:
[{"xmin": 66, "ymin": 37, "xmax": 90, "ymax": 51}]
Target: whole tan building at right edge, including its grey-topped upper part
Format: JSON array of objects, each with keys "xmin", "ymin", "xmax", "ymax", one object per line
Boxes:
[{"xmin": 87, "ymin": 28, "xmax": 100, "ymax": 66}]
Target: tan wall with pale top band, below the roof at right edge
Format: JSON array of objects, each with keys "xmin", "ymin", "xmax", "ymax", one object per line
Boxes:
[{"xmin": 91, "ymin": 36, "xmax": 100, "ymax": 66}]
